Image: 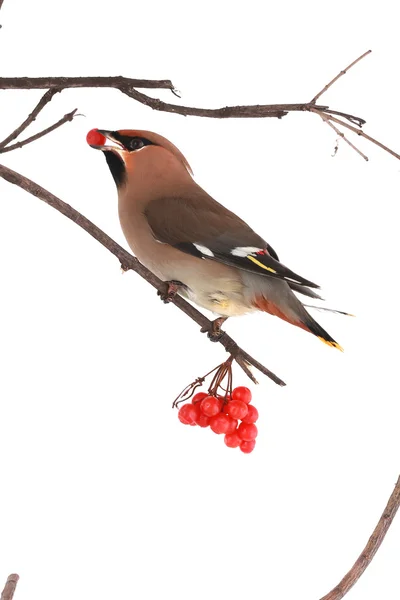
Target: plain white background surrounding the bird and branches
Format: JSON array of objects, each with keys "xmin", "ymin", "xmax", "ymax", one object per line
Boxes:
[{"xmin": 0, "ymin": 0, "xmax": 400, "ymax": 600}]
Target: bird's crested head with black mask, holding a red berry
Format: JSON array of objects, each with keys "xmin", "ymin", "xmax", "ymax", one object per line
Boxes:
[{"xmin": 86, "ymin": 129, "xmax": 192, "ymax": 188}]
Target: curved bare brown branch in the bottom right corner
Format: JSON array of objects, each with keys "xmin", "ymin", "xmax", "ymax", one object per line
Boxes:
[{"xmin": 320, "ymin": 477, "xmax": 400, "ymax": 600}]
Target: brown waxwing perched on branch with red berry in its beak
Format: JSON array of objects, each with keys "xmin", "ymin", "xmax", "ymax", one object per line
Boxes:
[{"xmin": 86, "ymin": 129, "xmax": 347, "ymax": 351}]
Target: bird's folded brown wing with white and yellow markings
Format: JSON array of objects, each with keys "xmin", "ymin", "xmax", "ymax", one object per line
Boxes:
[{"xmin": 144, "ymin": 188, "xmax": 319, "ymax": 288}]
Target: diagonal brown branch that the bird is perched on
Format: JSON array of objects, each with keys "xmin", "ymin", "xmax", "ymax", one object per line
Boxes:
[{"xmin": 0, "ymin": 165, "xmax": 285, "ymax": 386}]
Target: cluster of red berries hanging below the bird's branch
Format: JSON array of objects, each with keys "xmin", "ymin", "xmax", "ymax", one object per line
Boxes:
[{"xmin": 178, "ymin": 386, "xmax": 258, "ymax": 454}]
